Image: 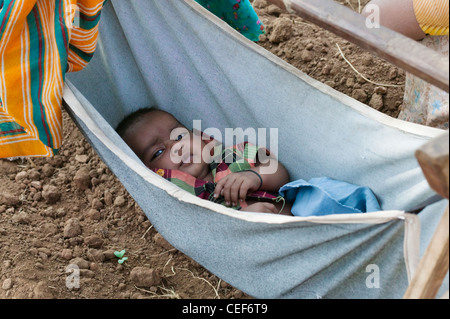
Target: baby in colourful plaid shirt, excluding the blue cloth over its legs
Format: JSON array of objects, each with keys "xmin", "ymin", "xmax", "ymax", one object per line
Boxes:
[{"xmin": 117, "ymin": 108, "xmax": 292, "ymax": 215}]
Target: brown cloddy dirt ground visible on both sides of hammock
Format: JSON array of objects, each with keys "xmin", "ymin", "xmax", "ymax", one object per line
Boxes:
[{"xmin": 0, "ymin": 0, "xmax": 405, "ymax": 299}]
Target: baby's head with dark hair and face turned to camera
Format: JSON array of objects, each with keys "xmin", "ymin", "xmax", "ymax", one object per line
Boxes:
[{"xmin": 124, "ymin": 111, "xmax": 211, "ymax": 179}]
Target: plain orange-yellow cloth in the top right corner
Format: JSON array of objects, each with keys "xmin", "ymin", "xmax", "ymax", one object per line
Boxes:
[{"xmin": 413, "ymin": 0, "xmax": 449, "ymax": 35}]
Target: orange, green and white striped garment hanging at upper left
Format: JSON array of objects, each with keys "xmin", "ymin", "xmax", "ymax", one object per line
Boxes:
[{"xmin": 0, "ymin": 0, "xmax": 107, "ymax": 158}]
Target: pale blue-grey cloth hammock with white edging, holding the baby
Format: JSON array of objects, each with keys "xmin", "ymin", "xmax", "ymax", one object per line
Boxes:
[{"xmin": 64, "ymin": 0, "xmax": 448, "ymax": 299}]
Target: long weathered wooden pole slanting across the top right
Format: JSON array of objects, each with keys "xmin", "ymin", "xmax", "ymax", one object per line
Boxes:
[{"xmin": 267, "ymin": 0, "xmax": 449, "ymax": 92}]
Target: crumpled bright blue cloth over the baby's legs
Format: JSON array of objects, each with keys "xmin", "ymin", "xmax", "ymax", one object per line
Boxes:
[{"xmin": 279, "ymin": 177, "xmax": 380, "ymax": 217}]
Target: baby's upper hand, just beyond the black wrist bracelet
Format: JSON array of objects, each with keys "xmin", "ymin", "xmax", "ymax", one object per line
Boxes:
[{"xmin": 214, "ymin": 171, "xmax": 261, "ymax": 206}]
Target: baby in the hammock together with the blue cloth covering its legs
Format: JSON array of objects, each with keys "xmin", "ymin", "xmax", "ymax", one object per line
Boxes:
[{"xmin": 117, "ymin": 108, "xmax": 380, "ymax": 217}]
